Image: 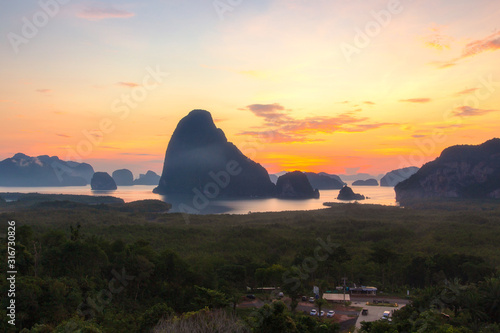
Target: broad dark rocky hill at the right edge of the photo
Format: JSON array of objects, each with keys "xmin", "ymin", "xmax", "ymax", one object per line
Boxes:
[{"xmin": 394, "ymin": 139, "xmax": 500, "ymax": 205}]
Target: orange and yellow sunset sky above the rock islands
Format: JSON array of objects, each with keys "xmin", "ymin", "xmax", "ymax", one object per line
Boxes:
[{"xmin": 0, "ymin": 0, "xmax": 500, "ymax": 176}]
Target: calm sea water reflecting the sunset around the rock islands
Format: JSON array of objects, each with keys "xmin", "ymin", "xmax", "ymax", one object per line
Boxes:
[{"xmin": 0, "ymin": 185, "xmax": 397, "ymax": 214}]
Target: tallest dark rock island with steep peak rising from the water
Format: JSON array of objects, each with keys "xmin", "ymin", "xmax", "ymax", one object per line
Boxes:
[{"xmin": 153, "ymin": 110, "xmax": 276, "ymax": 198}]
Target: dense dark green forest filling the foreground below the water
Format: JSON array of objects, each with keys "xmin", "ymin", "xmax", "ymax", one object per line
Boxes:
[{"xmin": 0, "ymin": 197, "xmax": 500, "ymax": 332}]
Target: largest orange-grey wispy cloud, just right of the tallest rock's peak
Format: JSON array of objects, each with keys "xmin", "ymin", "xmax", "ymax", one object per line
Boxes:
[{"xmin": 239, "ymin": 103, "xmax": 395, "ymax": 143}]
